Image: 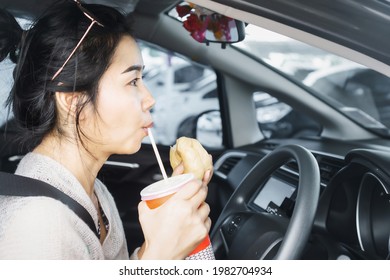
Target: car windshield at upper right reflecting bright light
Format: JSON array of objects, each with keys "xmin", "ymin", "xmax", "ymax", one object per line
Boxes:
[{"xmin": 234, "ymin": 25, "xmax": 390, "ymax": 136}]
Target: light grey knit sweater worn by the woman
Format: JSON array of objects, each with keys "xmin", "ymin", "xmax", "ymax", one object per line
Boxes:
[{"xmin": 0, "ymin": 153, "xmax": 135, "ymax": 259}]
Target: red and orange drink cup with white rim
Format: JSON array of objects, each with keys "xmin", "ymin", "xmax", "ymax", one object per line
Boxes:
[{"xmin": 141, "ymin": 174, "xmax": 215, "ymax": 260}]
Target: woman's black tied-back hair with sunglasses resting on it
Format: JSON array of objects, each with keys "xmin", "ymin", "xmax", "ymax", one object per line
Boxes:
[{"xmin": 0, "ymin": 0, "xmax": 132, "ymax": 149}]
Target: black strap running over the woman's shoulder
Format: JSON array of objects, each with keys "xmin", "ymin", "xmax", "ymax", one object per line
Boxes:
[{"xmin": 0, "ymin": 172, "xmax": 98, "ymax": 236}]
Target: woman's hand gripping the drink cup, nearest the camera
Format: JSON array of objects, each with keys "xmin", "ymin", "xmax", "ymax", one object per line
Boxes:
[{"xmin": 138, "ymin": 178, "xmax": 211, "ymax": 259}]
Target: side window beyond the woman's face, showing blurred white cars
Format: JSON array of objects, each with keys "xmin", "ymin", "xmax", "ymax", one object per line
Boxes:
[{"xmin": 139, "ymin": 40, "xmax": 222, "ymax": 146}]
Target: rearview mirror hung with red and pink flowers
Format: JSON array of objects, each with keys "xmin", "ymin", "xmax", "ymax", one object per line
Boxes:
[{"xmin": 176, "ymin": 2, "xmax": 245, "ymax": 47}]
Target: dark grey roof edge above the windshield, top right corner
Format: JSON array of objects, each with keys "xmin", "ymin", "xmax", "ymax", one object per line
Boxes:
[{"xmin": 206, "ymin": 0, "xmax": 390, "ymax": 76}]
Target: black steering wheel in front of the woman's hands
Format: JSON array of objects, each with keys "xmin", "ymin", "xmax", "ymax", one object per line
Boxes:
[{"xmin": 210, "ymin": 145, "xmax": 320, "ymax": 260}]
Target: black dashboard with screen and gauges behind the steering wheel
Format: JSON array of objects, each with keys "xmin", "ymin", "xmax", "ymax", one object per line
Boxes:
[{"xmin": 215, "ymin": 139, "xmax": 390, "ymax": 259}]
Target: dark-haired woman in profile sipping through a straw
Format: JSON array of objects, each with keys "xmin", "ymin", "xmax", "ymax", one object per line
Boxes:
[{"xmin": 0, "ymin": 1, "xmax": 211, "ymax": 259}]
